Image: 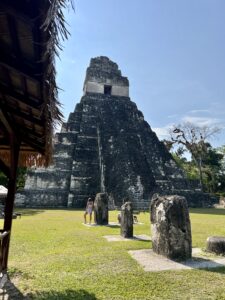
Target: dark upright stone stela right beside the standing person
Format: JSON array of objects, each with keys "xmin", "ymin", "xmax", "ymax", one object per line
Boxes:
[{"xmin": 94, "ymin": 193, "xmax": 109, "ymax": 225}]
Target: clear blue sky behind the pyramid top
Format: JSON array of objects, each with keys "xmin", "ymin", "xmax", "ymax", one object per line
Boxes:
[{"xmin": 57, "ymin": 0, "xmax": 225, "ymax": 146}]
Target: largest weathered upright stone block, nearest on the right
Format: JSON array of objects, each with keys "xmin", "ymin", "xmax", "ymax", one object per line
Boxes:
[{"xmin": 150, "ymin": 195, "xmax": 192, "ymax": 260}]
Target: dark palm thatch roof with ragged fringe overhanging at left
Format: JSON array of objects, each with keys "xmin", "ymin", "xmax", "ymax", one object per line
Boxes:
[{"xmin": 0, "ymin": 0, "xmax": 74, "ymax": 166}]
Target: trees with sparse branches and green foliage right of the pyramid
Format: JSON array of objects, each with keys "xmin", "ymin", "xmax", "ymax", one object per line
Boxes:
[{"xmin": 164, "ymin": 123, "xmax": 225, "ymax": 193}]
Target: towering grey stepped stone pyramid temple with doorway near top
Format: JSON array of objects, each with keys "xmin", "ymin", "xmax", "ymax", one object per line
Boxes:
[{"xmin": 16, "ymin": 56, "xmax": 216, "ymax": 209}]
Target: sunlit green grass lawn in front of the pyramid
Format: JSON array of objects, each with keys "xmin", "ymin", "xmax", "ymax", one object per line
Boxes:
[{"xmin": 4, "ymin": 209, "xmax": 225, "ymax": 300}]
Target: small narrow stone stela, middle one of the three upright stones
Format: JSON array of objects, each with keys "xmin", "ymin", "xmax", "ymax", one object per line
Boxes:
[{"xmin": 120, "ymin": 202, "xmax": 133, "ymax": 238}]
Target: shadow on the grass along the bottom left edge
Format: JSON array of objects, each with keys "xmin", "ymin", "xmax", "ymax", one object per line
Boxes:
[{"xmin": 0, "ymin": 281, "xmax": 97, "ymax": 300}]
